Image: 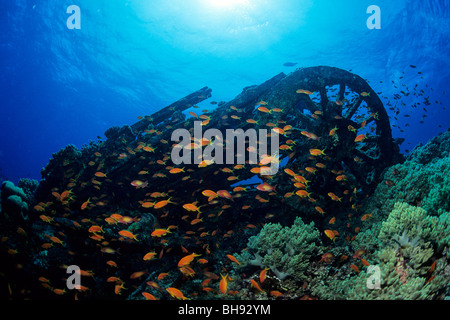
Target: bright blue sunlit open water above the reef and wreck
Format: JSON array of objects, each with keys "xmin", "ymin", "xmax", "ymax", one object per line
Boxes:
[{"xmin": 0, "ymin": 0, "xmax": 450, "ymax": 181}]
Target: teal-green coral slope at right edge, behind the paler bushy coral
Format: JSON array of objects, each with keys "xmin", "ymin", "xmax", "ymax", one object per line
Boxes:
[{"xmin": 356, "ymin": 131, "xmax": 450, "ymax": 248}]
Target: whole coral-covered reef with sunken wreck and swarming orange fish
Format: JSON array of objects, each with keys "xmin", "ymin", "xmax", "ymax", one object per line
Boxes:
[{"xmin": 0, "ymin": 66, "xmax": 450, "ymax": 299}]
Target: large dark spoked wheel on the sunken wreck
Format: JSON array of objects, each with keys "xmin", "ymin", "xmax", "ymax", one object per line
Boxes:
[{"xmin": 260, "ymin": 66, "xmax": 395, "ymax": 191}]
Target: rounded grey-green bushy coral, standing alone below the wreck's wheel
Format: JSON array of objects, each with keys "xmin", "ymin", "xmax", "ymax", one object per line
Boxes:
[{"xmin": 237, "ymin": 217, "xmax": 320, "ymax": 280}]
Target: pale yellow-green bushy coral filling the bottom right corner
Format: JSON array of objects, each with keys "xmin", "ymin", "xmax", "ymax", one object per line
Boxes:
[{"xmin": 312, "ymin": 202, "xmax": 450, "ymax": 300}]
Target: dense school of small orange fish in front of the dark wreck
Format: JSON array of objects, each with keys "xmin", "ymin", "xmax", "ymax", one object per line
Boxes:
[{"xmin": 1, "ymin": 75, "xmax": 442, "ymax": 300}]
